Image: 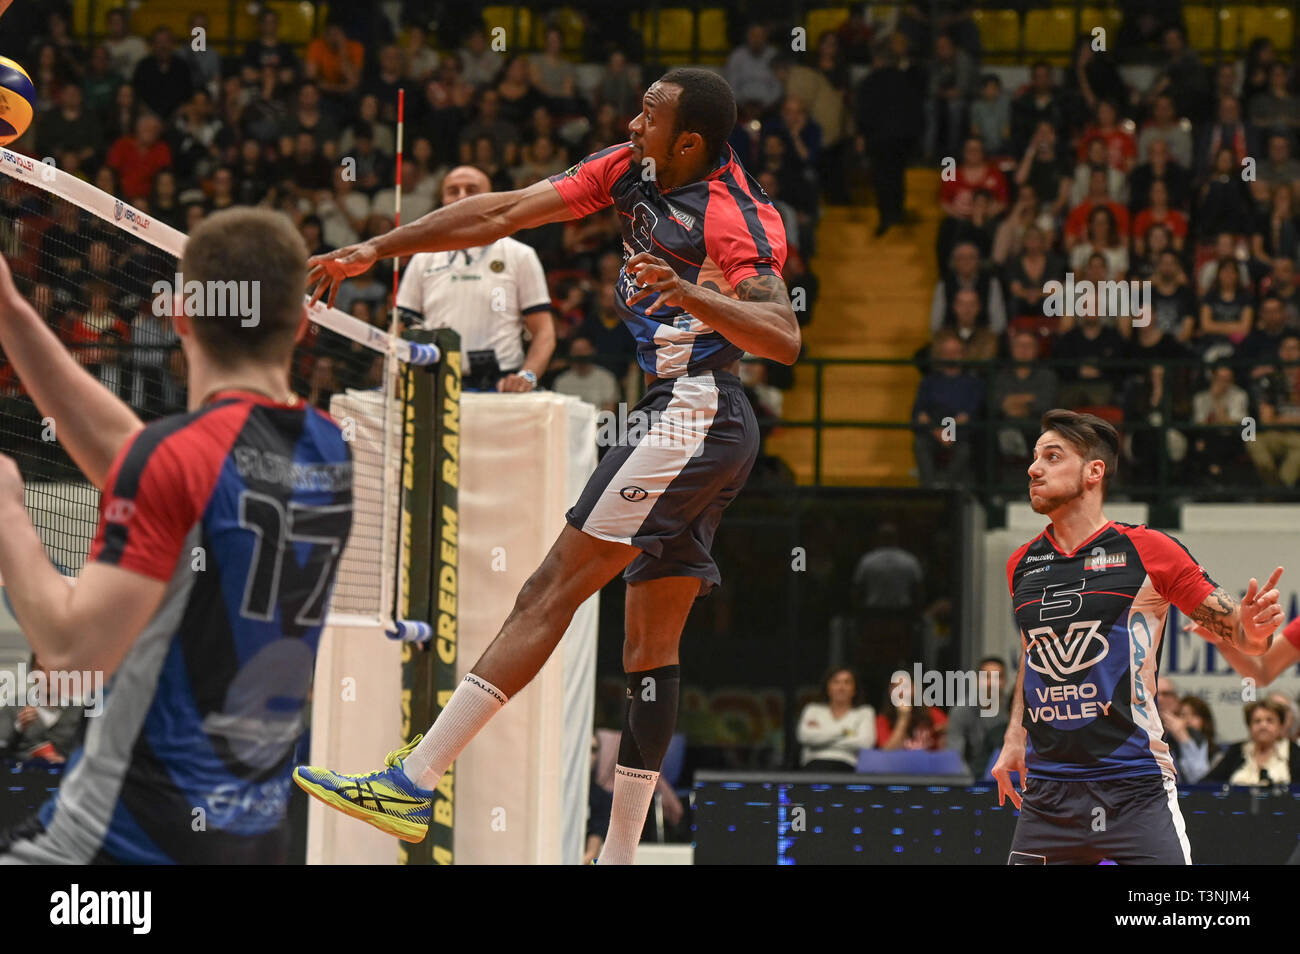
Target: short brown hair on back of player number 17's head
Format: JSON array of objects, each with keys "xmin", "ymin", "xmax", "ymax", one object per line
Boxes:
[{"xmin": 181, "ymin": 208, "xmax": 307, "ymax": 368}]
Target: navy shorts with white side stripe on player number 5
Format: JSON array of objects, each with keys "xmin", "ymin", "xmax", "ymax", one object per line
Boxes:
[{"xmin": 1006, "ymin": 775, "xmax": 1192, "ymax": 864}]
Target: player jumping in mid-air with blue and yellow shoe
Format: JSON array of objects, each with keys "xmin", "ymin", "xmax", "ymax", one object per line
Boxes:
[{"xmin": 295, "ymin": 69, "xmax": 800, "ymax": 864}]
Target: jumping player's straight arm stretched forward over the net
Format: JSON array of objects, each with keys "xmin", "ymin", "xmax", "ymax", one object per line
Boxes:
[{"xmin": 307, "ymin": 179, "xmax": 575, "ymax": 305}]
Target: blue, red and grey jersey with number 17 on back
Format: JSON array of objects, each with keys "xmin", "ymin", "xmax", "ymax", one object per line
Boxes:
[{"xmin": 31, "ymin": 391, "xmax": 352, "ymax": 863}]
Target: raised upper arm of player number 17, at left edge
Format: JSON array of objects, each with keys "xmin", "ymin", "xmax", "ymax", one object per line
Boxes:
[{"xmin": 0, "ymin": 256, "xmax": 144, "ymax": 490}]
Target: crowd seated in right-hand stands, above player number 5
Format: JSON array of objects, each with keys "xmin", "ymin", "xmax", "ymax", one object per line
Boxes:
[{"xmin": 915, "ymin": 22, "xmax": 1300, "ymax": 494}]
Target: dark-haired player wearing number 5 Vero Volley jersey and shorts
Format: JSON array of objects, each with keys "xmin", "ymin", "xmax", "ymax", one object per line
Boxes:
[{"xmin": 993, "ymin": 411, "xmax": 1282, "ymax": 864}]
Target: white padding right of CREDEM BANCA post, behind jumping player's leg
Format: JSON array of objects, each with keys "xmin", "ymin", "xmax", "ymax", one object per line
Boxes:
[{"xmin": 455, "ymin": 394, "xmax": 597, "ymax": 864}]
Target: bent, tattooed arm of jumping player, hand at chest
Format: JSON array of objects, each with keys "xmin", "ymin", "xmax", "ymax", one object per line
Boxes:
[{"xmin": 627, "ymin": 252, "xmax": 803, "ymax": 364}]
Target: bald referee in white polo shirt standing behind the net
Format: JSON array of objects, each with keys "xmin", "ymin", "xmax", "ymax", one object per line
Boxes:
[{"xmin": 398, "ymin": 165, "xmax": 555, "ymax": 391}]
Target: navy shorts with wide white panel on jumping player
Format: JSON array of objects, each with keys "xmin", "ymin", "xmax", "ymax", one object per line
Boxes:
[{"xmin": 564, "ymin": 370, "xmax": 758, "ymax": 595}]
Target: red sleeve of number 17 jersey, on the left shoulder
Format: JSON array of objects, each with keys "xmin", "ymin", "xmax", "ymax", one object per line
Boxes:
[{"xmin": 90, "ymin": 419, "xmax": 210, "ymax": 581}]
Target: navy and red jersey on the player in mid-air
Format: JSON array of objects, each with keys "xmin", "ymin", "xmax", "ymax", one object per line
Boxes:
[{"xmin": 550, "ymin": 143, "xmax": 785, "ymax": 378}]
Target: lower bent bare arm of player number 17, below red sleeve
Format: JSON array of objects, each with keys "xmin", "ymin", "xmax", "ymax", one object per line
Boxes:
[{"xmin": 0, "ymin": 454, "xmax": 166, "ymax": 678}]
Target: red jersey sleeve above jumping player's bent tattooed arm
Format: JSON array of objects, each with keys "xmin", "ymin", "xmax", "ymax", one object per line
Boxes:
[{"xmin": 705, "ymin": 175, "xmax": 785, "ymax": 289}]
